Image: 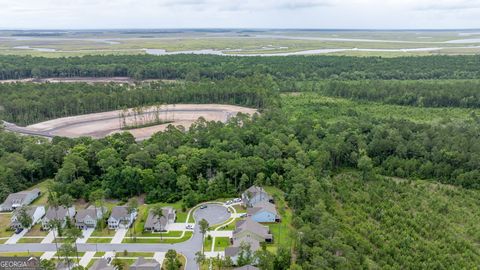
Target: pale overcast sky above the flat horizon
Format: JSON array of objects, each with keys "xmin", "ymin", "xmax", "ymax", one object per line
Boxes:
[{"xmin": 0, "ymin": 0, "xmax": 480, "ymax": 29}]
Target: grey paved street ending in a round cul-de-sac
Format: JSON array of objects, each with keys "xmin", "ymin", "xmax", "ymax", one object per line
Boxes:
[{"xmin": 0, "ymin": 204, "xmax": 230, "ymax": 270}]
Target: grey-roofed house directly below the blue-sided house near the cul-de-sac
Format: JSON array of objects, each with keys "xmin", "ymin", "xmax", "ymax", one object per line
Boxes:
[{"xmin": 232, "ymin": 217, "xmax": 273, "ymax": 246}]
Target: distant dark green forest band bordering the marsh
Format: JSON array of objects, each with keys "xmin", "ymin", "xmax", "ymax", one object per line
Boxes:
[{"xmin": 0, "ymin": 55, "xmax": 480, "ymax": 80}]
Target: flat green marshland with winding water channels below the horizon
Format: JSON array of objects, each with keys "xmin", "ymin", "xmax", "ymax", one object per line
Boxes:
[{"xmin": 0, "ymin": 29, "xmax": 480, "ymax": 57}]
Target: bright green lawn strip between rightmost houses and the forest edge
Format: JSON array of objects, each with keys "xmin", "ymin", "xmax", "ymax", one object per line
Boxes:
[{"xmin": 265, "ymin": 187, "xmax": 294, "ymax": 251}]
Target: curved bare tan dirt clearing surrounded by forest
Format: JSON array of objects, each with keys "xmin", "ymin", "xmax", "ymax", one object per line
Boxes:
[{"xmin": 21, "ymin": 104, "xmax": 257, "ymax": 140}]
